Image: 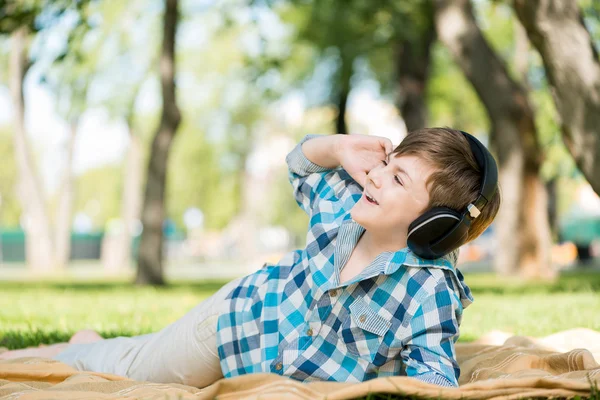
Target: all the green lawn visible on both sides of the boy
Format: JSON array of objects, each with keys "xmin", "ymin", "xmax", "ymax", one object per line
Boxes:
[{"xmin": 0, "ymin": 272, "xmax": 600, "ymax": 399}]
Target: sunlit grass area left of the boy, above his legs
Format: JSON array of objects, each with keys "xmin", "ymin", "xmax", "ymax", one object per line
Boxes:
[{"xmin": 0, "ymin": 281, "xmax": 225, "ymax": 349}]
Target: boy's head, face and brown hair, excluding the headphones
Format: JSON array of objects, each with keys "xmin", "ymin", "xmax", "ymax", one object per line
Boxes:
[{"xmin": 352, "ymin": 128, "xmax": 500, "ymax": 248}]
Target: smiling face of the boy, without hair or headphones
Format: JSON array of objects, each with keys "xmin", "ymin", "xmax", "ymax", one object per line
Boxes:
[{"xmin": 351, "ymin": 154, "xmax": 435, "ymax": 238}]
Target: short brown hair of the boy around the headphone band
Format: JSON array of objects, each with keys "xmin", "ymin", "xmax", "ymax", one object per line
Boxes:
[{"xmin": 392, "ymin": 128, "xmax": 501, "ymax": 242}]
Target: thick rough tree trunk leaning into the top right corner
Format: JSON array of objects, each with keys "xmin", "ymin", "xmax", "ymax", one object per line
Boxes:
[{"xmin": 513, "ymin": 0, "xmax": 600, "ymax": 194}]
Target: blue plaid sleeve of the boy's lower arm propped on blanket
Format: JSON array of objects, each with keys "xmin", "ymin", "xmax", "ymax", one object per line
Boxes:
[{"xmin": 401, "ymin": 281, "xmax": 462, "ymax": 387}]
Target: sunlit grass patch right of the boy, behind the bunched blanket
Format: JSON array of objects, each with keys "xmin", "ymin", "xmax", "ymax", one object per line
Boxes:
[{"xmin": 460, "ymin": 271, "xmax": 600, "ymax": 341}]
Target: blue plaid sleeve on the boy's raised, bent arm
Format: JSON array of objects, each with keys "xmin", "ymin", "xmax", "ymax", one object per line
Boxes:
[{"xmin": 285, "ymin": 135, "xmax": 362, "ymax": 215}]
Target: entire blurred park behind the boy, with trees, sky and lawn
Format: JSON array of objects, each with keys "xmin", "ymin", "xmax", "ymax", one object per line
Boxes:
[{"xmin": 0, "ymin": 0, "xmax": 600, "ymax": 348}]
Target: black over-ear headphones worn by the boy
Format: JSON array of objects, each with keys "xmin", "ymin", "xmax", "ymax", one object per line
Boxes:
[{"xmin": 407, "ymin": 131, "xmax": 498, "ymax": 259}]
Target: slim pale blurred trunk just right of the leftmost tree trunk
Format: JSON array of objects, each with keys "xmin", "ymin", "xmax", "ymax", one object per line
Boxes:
[{"xmin": 55, "ymin": 118, "xmax": 78, "ymax": 269}]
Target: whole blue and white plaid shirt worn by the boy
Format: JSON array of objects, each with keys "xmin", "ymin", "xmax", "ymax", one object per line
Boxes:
[{"xmin": 217, "ymin": 135, "xmax": 473, "ymax": 386}]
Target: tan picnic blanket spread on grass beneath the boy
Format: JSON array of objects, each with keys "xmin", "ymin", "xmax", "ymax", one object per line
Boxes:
[{"xmin": 0, "ymin": 329, "xmax": 600, "ymax": 400}]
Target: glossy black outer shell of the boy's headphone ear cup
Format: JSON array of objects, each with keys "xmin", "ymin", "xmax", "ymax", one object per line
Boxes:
[{"xmin": 407, "ymin": 207, "xmax": 462, "ymax": 259}]
